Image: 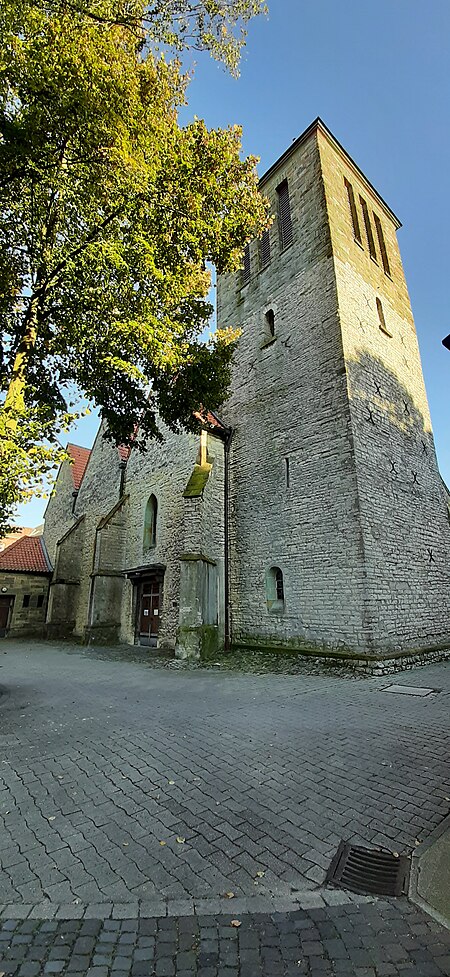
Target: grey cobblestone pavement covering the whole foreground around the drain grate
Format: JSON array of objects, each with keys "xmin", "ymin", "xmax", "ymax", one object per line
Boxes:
[{"xmin": 0, "ymin": 641, "xmax": 450, "ymax": 977}]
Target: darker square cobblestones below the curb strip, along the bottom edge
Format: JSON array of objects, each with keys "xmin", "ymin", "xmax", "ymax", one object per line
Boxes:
[{"xmin": 0, "ymin": 901, "xmax": 450, "ymax": 977}]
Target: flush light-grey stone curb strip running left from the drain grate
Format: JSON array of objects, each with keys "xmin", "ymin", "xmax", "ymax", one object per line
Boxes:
[{"xmin": 0, "ymin": 888, "xmax": 377, "ymax": 925}]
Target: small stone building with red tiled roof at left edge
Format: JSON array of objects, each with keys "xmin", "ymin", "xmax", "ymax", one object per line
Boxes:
[{"xmin": 0, "ymin": 536, "xmax": 53, "ymax": 637}]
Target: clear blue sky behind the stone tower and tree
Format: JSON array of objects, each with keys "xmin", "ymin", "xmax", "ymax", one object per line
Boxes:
[{"xmin": 17, "ymin": 0, "xmax": 450, "ymax": 525}]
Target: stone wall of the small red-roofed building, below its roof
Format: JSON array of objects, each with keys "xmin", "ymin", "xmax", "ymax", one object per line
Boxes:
[{"xmin": 0, "ymin": 572, "xmax": 49, "ymax": 637}]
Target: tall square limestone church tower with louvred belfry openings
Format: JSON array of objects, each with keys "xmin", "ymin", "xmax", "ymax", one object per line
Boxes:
[{"xmin": 218, "ymin": 119, "xmax": 450, "ymax": 657}]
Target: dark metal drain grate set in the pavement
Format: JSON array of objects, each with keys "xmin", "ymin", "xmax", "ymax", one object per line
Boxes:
[{"xmin": 325, "ymin": 841, "xmax": 409, "ymax": 896}]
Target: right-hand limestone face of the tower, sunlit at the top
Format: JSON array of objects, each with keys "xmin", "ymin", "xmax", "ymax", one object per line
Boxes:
[{"xmin": 319, "ymin": 127, "xmax": 450, "ymax": 650}]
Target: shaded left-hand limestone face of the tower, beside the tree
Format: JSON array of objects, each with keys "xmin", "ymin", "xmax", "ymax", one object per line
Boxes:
[{"xmin": 218, "ymin": 127, "xmax": 367, "ymax": 649}]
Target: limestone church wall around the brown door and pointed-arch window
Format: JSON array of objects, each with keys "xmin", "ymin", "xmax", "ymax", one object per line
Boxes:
[{"xmin": 120, "ymin": 428, "xmax": 198, "ymax": 648}]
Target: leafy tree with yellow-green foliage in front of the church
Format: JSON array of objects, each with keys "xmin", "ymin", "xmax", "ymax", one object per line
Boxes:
[{"xmin": 0, "ymin": 0, "xmax": 267, "ymax": 530}]
